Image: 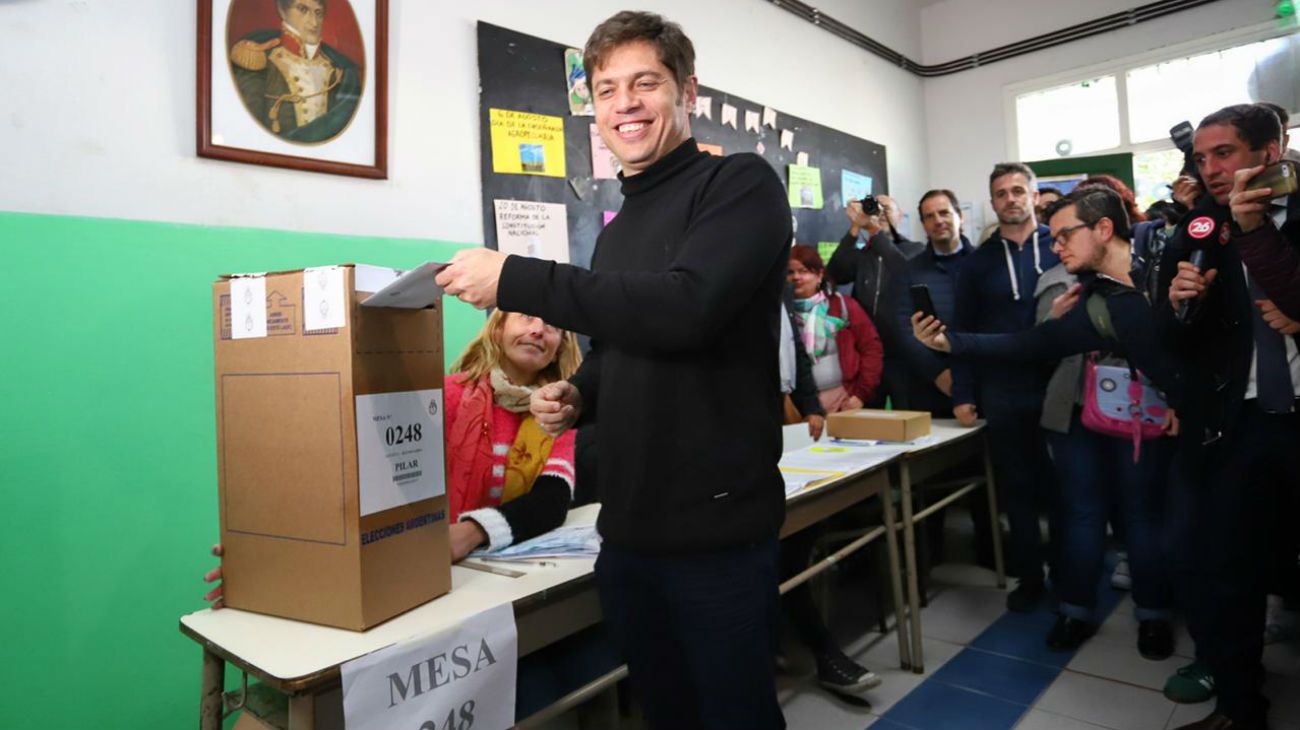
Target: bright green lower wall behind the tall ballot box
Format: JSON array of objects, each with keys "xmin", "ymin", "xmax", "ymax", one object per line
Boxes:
[{"xmin": 0, "ymin": 213, "xmax": 482, "ymax": 730}]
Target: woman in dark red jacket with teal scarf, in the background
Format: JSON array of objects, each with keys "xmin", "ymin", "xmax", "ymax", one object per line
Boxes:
[{"xmin": 789, "ymin": 244, "xmax": 884, "ymax": 413}]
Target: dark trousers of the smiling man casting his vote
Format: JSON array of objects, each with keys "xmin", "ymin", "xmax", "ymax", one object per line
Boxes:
[{"xmin": 595, "ymin": 538, "xmax": 785, "ymax": 730}]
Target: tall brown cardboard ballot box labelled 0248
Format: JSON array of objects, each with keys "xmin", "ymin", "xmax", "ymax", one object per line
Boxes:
[{"xmin": 213, "ymin": 265, "xmax": 451, "ymax": 630}]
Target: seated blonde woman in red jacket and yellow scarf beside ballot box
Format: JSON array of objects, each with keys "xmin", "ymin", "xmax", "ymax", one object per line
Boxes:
[{"xmin": 204, "ymin": 309, "xmax": 582, "ymax": 608}]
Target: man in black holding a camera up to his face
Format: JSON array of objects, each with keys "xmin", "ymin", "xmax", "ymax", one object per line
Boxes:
[{"xmin": 826, "ymin": 195, "xmax": 926, "ymax": 408}]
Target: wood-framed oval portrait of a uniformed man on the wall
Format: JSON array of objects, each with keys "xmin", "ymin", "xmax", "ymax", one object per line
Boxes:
[{"xmin": 198, "ymin": 0, "xmax": 389, "ymax": 179}]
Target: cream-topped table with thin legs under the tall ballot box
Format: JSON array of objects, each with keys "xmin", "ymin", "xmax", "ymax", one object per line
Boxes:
[{"xmin": 181, "ymin": 425, "xmax": 910, "ymax": 730}]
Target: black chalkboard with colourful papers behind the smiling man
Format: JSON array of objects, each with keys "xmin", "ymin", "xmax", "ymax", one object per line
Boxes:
[{"xmin": 478, "ymin": 22, "xmax": 889, "ymax": 266}]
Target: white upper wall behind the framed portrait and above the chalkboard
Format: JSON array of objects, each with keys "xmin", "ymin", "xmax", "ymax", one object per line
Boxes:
[{"xmin": 0, "ymin": 0, "xmax": 927, "ymax": 242}]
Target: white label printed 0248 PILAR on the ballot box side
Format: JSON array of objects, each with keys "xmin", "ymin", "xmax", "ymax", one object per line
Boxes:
[{"xmin": 356, "ymin": 390, "xmax": 447, "ymax": 517}]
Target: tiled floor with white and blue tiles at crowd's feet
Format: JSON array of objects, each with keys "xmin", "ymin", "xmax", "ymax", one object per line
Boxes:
[{"xmin": 781, "ymin": 553, "xmax": 1300, "ymax": 730}]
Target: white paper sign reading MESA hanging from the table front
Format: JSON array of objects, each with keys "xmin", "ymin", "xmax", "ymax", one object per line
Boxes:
[{"xmin": 341, "ymin": 603, "xmax": 519, "ymax": 730}]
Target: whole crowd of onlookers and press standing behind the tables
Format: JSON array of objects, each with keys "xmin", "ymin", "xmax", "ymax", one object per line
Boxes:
[{"xmin": 764, "ymin": 104, "xmax": 1300, "ymax": 729}]
